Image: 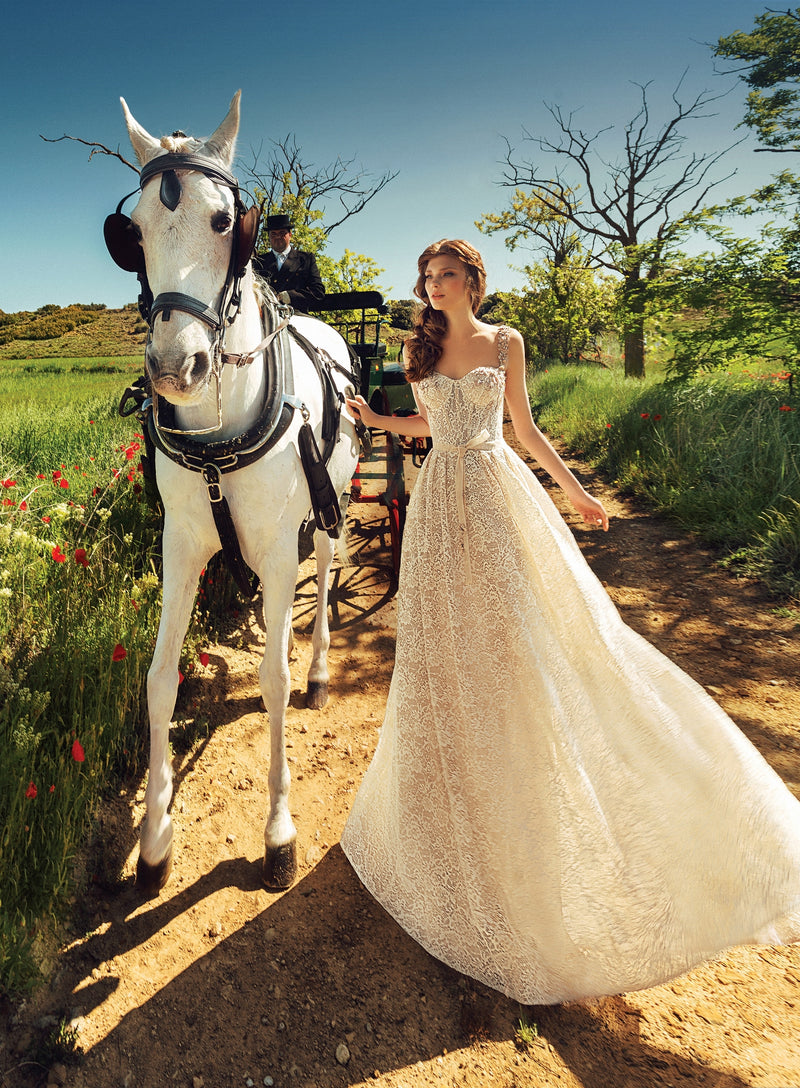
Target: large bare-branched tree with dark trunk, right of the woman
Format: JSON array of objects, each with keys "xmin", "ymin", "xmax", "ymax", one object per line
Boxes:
[{"xmin": 495, "ymin": 81, "xmax": 740, "ymax": 378}]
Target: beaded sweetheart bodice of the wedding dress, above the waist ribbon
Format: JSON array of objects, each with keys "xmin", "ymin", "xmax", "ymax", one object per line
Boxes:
[{"xmin": 418, "ymin": 325, "xmax": 508, "ymax": 449}]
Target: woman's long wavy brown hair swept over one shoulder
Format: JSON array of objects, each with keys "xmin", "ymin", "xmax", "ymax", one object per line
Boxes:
[{"xmin": 403, "ymin": 238, "xmax": 487, "ymax": 382}]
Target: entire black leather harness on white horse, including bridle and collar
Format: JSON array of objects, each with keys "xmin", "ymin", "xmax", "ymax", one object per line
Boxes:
[{"xmin": 103, "ymin": 147, "xmax": 359, "ymax": 598}]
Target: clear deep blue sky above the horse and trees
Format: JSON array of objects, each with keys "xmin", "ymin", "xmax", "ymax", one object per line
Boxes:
[{"xmin": 0, "ymin": 0, "xmax": 787, "ymax": 311}]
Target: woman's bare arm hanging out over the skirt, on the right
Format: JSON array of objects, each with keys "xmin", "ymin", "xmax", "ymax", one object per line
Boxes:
[{"xmin": 505, "ymin": 330, "xmax": 608, "ymax": 530}]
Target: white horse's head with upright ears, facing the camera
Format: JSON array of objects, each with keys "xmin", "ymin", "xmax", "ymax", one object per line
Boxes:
[{"xmin": 121, "ymin": 91, "xmax": 246, "ymax": 404}]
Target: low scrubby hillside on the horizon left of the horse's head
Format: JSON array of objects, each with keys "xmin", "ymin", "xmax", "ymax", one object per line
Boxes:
[{"xmin": 0, "ymin": 302, "xmax": 147, "ymax": 359}]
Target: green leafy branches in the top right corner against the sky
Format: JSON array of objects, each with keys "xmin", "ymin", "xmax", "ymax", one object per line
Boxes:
[{"xmin": 715, "ymin": 8, "xmax": 800, "ymax": 149}]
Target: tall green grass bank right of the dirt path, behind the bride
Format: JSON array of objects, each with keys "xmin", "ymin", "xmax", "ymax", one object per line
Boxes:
[{"xmin": 530, "ymin": 367, "xmax": 800, "ymax": 594}]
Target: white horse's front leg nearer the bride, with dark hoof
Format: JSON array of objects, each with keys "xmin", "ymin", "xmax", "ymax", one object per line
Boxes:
[{"xmin": 259, "ymin": 541, "xmax": 297, "ymax": 889}]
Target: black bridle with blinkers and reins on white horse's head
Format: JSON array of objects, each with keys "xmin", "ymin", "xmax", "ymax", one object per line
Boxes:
[{"xmin": 102, "ymin": 152, "xmax": 265, "ymax": 434}]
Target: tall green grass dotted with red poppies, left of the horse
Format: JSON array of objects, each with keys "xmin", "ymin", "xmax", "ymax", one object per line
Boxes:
[{"xmin": 0, "ymin": 364, "xmax": 167, "ymax": 990}]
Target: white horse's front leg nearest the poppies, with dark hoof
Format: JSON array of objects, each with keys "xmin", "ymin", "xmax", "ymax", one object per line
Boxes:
[{"xmin": 136, "ymin": 527, "xmax": 208, "ymax": 895}]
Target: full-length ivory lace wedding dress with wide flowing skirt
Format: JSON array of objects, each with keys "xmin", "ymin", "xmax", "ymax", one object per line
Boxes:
[{"xmin": 342, "ymin": 330, "xmax": 800, "ymax": 1004}]
